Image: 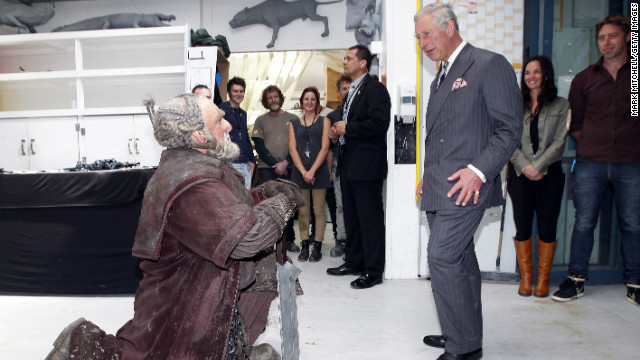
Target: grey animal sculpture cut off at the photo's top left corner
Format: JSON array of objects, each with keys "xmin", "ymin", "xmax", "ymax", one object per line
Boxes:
[{"xmin": 0, "ymin": 1, "xmax": 55, "ymax": 33}]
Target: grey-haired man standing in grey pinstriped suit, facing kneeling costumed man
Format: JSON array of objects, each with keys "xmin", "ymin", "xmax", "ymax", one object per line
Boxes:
[{"xmin": 414, "ymin": 3, "xmax": 522, "ymax": 360}]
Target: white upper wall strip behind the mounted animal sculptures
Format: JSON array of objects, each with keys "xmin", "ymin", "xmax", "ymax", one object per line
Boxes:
[{"xmin": 0, "ymin": 0, "xmax": 356, "ymax": 52}]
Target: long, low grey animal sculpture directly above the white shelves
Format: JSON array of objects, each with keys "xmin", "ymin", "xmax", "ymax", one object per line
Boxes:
[{"xmin": 51, "ymin": 13, "xmax": 176, "ymax": 32}]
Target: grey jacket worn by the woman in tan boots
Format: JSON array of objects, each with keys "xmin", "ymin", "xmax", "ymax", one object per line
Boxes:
[{"xmin": 511, "ymin": 97, "xmax": 570, "ymax": 176}]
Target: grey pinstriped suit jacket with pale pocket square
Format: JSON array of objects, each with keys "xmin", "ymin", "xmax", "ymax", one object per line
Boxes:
[{"xmin": 421, "ymin": 44, "xmax": 522, "ymax": 211}]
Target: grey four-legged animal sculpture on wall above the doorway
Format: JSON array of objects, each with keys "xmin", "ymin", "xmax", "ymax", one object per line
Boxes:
[{"xmin": 229, "ymin": 0, "xmax": 342, "ymax": 48}]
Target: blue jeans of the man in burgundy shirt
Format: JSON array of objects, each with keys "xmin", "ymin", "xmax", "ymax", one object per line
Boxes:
[{"xmin": 569, "ymin": 158, "xmax": 640, "ymax": 284}]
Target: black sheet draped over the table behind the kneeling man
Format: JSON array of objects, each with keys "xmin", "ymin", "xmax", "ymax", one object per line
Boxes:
[{"xmin": 0, "ymin": 169, "xmax": 154, "ymax": 294}]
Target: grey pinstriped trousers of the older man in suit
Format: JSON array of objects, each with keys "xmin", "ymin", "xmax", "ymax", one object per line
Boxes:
[{"xmin": 427, "ymin": 209, "xmax": 484, "ymax": 354}]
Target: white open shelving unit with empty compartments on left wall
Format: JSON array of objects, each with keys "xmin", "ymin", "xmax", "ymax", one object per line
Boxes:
[{"xmin": 0, "ymin": 26, "xmax": 189, "ymax": 117}]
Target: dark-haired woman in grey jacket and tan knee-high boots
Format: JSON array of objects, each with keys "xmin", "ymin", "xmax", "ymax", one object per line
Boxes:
[{"xmin": 508, "ymin": 56, "xmax": 570, "ymax": 297}]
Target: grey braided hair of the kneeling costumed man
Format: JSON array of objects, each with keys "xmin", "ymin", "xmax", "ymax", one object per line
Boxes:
[{"xmin": 144, "ymin": 94, "xmax": 204, "ymax": 149}]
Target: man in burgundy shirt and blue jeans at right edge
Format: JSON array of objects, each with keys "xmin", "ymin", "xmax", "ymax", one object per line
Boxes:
[{"xmin": 552, "ymin": 15, "xmax": 640, "ymax": 305}]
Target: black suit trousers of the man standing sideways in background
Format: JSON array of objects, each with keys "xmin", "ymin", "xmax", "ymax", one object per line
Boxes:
[{"xmin": 340, "ymin": 176, "xmax": 385, "ymax": 278}]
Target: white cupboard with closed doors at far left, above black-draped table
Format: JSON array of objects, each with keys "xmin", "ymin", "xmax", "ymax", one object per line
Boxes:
[{"xmin": 0, "ymin": 116, "xmax": 79, "ymax": 170}]
